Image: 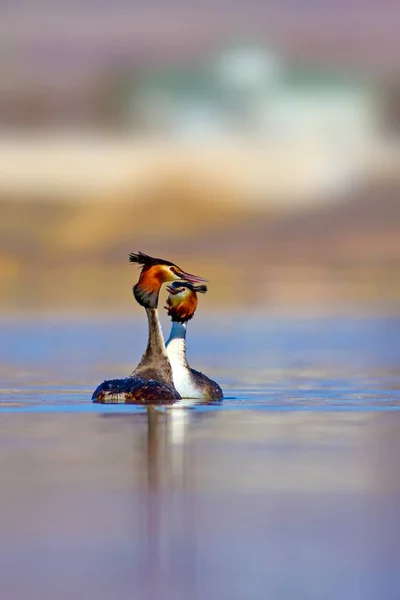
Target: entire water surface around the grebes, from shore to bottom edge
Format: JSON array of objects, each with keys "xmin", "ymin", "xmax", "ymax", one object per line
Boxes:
[{"xmin": 0, "ymin": 314, "xmax": 400, "ymax": 600}]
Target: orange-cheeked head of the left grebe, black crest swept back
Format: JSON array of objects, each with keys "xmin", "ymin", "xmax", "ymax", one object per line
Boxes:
[{"xmin": 129, "ymin": 252, "xmax": 207, "ymax": 308}]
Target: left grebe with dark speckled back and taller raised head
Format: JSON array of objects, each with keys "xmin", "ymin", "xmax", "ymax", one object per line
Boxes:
[{"xmin": 92, "ymin": 252, "xmax": 206, "ymax": 404}]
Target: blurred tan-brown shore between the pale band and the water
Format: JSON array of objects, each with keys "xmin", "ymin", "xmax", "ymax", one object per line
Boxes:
[{"xmin": 0, "ymin": 177, "xmax": 400, "ymax": 313}]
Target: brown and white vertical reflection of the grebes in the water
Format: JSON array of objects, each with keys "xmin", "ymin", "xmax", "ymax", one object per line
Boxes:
[{"xmin": 101, "ymin": 400, "xmax": 219, "ymax": 600}]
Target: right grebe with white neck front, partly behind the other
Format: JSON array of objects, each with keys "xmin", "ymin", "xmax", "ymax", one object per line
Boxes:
[{"xmin": 165, "ymin": 281, "xmax": 223, "ymax": 400}]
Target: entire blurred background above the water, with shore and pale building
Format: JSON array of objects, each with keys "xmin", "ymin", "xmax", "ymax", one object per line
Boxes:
[{"xmin": 0, "ymin": 0, "xmax": 400, "ymax": 313}]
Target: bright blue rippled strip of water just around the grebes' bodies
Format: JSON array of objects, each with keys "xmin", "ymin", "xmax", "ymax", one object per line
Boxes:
[{"xmin": 0, "ymin": 314, "xmax": 400, "ymax": 411}]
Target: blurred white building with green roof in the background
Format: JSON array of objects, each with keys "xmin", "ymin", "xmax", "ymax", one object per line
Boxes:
[{"xmin": 121, "ymin": 47, "xmax": 379, "ymax": 195}]
